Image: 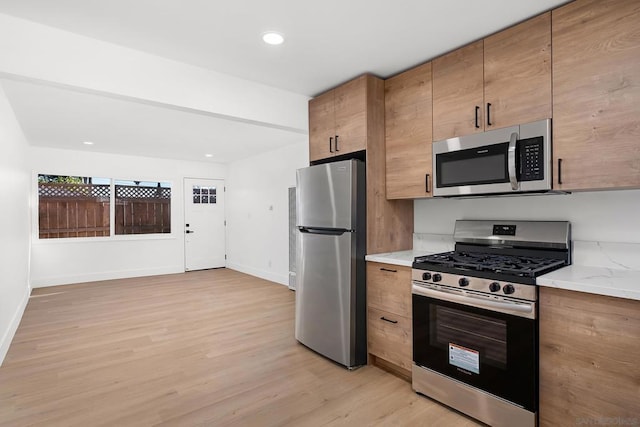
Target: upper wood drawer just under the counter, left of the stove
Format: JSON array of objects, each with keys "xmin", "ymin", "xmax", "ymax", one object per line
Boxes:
[{"xmin": 367, "ymin": 262, "xmax": 411, "ymax": 318}]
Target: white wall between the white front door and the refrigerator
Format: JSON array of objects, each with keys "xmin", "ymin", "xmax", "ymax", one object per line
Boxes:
[{"xmin": 227, "ymin": 142, "xmax": 309, "ymax": 285}]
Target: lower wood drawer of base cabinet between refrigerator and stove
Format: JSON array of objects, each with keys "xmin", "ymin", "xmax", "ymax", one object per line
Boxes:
[{"xmin": 367, "ymin": 307, "xmax": 413, "ymax": 370}]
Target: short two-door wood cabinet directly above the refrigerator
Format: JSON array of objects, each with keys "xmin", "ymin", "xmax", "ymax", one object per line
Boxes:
[{"xmin": 309, "ymin": 74, "xmax": 368, "ymax": 161}]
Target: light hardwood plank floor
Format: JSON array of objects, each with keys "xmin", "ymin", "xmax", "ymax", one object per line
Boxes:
[{"xmin": 0, "ymin": 269, "xmax": 476, "ymax": 426}]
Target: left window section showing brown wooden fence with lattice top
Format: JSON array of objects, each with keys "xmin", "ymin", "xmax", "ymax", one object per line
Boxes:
[{"xmin": 38, "ymin": 175, "xmax": 111, "ymax": 239}]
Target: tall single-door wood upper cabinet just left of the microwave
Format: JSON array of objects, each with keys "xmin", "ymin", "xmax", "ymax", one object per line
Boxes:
[{"xmin": 385, "ymin": 62, "xmax": 433, "ymax": 199}]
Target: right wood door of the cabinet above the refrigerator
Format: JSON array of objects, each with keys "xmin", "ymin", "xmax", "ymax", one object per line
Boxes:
[{"xmin": 334, "ymin": 75, "xmax": 371, "ymax": 155}]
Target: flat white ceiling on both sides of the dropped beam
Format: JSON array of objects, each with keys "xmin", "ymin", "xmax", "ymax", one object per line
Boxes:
[{"xmin": 0, "ymin": 0, "xmax": 566, "ymax": 162}]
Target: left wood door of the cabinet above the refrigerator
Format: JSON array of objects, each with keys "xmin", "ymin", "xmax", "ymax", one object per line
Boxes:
[{"xmin": 309, "ymin": 91, "xmax": 335, "ymax": 161}]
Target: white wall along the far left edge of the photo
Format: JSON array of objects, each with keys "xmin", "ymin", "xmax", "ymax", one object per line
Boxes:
[{"xmin": 0, "ymin": 85, "xmax": 30, "ymax": 364}]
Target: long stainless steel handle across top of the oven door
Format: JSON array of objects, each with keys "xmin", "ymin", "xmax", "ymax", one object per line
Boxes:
[{"xmin": 411, "ymin": 285, "xmax": 536, "ymax": 319}]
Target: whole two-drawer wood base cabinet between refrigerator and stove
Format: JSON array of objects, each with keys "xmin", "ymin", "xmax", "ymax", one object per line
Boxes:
[{"xmin": 367, "ymin": 262, "xmax": 413, "ymax": 379}]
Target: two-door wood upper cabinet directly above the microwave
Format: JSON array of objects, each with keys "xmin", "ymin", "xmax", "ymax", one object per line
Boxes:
[{"xmin": 432, "ymin": 12, "xmax": 551, "ymax": 141}]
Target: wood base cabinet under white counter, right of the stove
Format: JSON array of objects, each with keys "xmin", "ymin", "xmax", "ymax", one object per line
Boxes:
[{"xmin": 539, "ymin": 287, "xmax": 640, "ymax": 427}]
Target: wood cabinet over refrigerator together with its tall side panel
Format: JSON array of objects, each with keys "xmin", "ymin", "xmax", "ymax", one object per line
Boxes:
[{"xmin": 309, "ymin": 74, "xmax": 413, "ymax": 254}]
